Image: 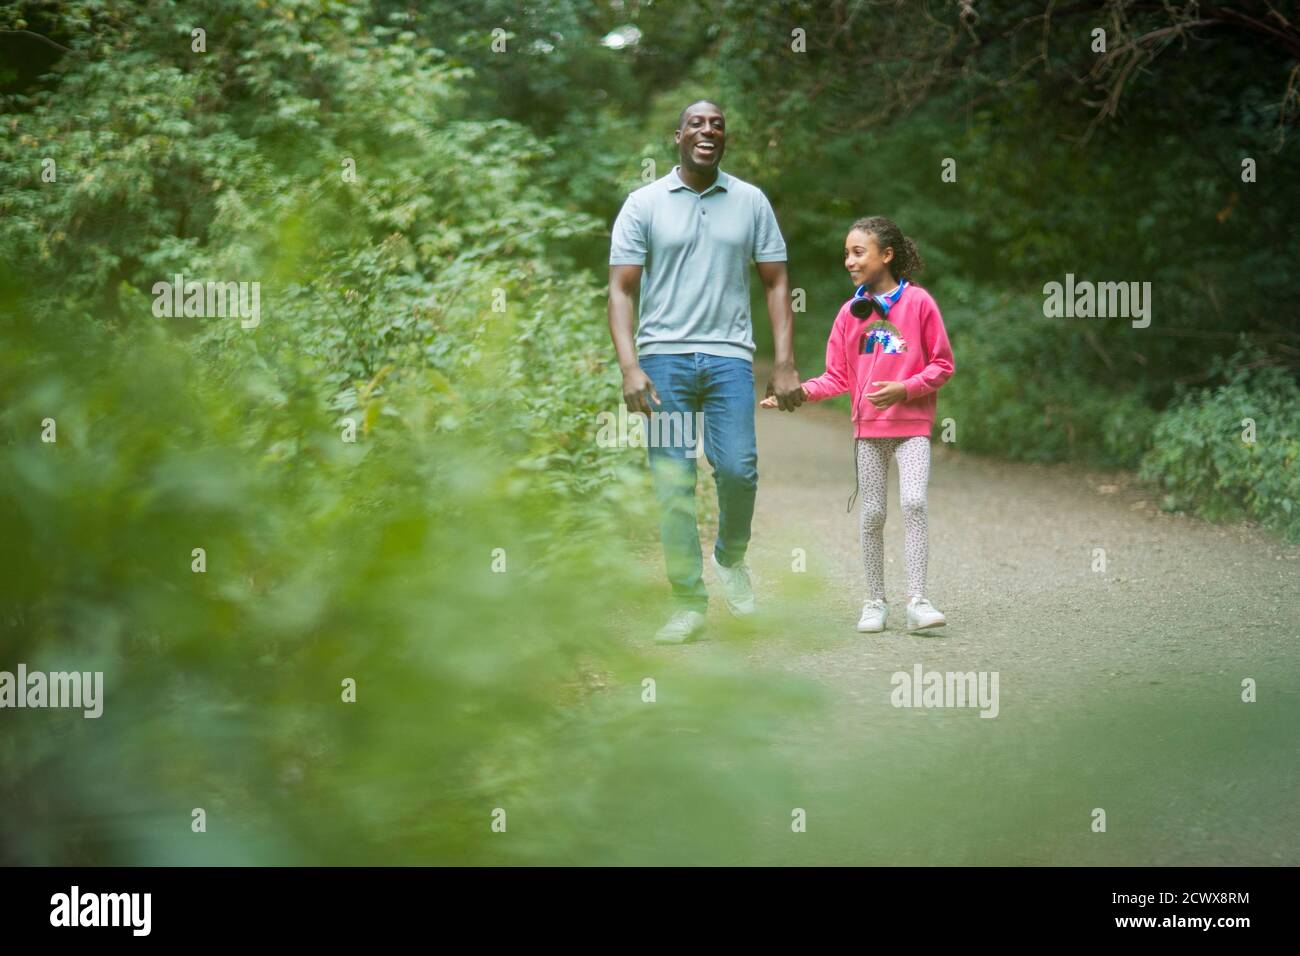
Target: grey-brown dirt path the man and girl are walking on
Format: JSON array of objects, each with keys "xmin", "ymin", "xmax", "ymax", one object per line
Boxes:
[{"xmin": 634, "ymin": 378, "xmax": 1300, "ymax": 865}]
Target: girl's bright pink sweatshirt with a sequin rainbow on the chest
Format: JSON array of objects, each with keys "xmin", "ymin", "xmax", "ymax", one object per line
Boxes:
[{"xmin": 803, "ymin": 282, "xmax": 953, "ymax": 438}]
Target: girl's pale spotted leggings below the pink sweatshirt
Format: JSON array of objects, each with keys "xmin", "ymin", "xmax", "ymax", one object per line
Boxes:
[{"xmin": 857, "ymin": 436, "xmax": 930, "ymax": 600}]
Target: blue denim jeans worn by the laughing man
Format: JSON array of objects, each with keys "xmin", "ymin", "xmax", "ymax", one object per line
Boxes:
[{"xmin": 641, "ymin": 352, "xmax": 758, "ymax": 613}]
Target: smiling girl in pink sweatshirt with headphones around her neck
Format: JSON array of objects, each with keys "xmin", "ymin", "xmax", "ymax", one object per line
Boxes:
[{"xmin": 761, "ymin": 216, "xmax": 953, "ymax": 632}]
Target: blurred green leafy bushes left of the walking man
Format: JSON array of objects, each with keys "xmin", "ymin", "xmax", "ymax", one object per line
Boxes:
[{"xmin": 0, "ymin": 3, "xmax": 832, "ymax": 864}]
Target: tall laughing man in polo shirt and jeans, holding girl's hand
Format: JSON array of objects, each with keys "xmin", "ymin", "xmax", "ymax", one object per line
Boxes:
[{"xmin": 608, "ymin": 100, "xmax": 803, "ymax": 644}]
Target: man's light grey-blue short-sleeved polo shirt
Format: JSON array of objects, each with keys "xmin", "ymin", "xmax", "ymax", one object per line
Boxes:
[{"xmin": 610, "ymin": 166, "xmax": 785, "ymax": 362}]
